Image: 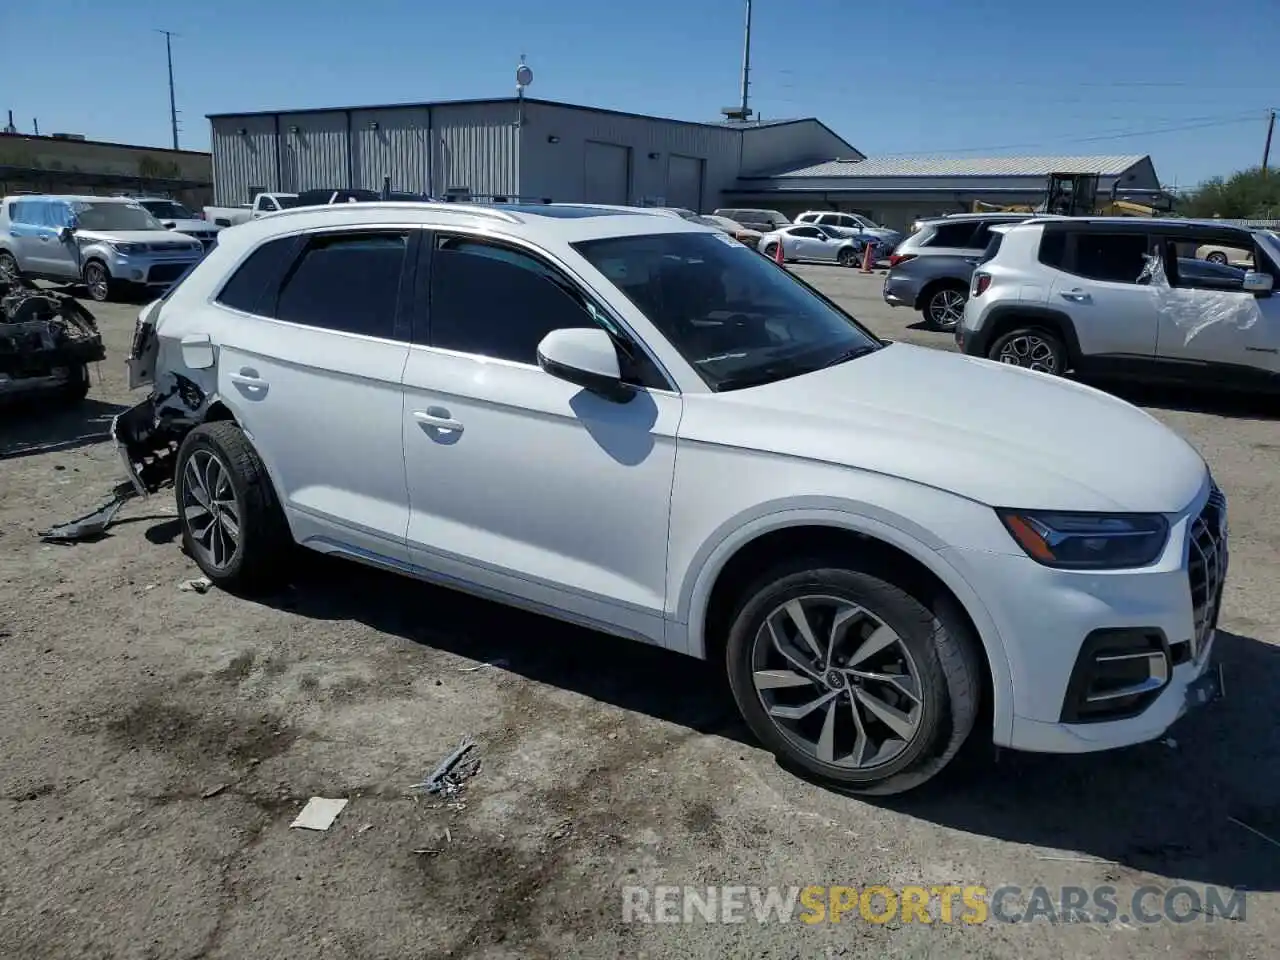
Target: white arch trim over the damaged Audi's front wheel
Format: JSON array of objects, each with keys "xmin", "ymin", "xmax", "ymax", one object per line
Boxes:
[{"xmin": 667, "ymin": 498, "xmax": 1014, "ymax": 744}]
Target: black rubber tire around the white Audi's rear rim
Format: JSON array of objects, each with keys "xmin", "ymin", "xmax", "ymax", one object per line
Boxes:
[{"xmin": 174, "ymin": 420, "xmax": 293, "ymax": 594}]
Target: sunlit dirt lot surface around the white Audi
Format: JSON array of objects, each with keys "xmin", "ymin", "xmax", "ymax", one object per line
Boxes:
[{"xmin": 0, "ymin": 268, "xmax": 1280, "ymax": 960}]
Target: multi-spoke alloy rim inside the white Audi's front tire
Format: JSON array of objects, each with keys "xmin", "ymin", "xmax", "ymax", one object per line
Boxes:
[{"xmin": 751, "ymin": 595, "xmax": 923, "ymax": 769}]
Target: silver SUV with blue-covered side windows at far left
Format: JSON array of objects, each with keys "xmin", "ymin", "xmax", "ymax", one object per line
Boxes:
[{"xmin": 0, "ymin": 195, "xmax": 205, "ymax": 301}]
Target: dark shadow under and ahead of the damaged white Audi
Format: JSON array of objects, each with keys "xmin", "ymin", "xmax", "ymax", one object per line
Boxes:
[{"xmin": 209, "ymin": 542, "xmax": 1280, "ymax": 891}]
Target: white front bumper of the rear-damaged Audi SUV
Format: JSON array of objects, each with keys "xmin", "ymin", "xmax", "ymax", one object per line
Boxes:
[{"xmin": 945, "ymin": 490, "xmax": 1228, "ymax": 753}]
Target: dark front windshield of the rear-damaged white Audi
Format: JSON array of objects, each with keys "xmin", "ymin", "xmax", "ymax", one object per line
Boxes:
[{"xmin": 573, "ymin": 233, "xmax": 883, "ymax": 392}]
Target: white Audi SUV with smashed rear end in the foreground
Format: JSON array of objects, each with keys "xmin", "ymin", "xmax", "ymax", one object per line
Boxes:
[{"xmin": 113, "ymin": 204, "xmax": 1226, "ymax": 794}]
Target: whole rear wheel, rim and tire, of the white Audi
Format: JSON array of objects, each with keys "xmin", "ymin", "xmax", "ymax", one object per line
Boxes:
[{"xmin": 174, "ymin": 421, "xmax": 292, "ymax": 591}]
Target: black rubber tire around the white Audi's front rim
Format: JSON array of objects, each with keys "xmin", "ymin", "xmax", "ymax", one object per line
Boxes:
[{"xmin": 726, "ymin": 557, "xmax": 983, "ymax": 796}]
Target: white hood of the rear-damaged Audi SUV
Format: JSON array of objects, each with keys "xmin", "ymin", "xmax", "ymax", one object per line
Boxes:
[{"xmin": 680, "ymin": 343, "xmax": 1207, "ymax": 513}]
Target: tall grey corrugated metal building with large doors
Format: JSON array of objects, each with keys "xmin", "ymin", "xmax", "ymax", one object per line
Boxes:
[{"xmin": 209, "ymin": 97, "xmax": 863, "ymax": 211}]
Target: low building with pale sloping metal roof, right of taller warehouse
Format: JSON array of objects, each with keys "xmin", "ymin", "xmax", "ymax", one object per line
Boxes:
[{"xmin": 730, "ymin": 155, "xmax": 1160, "ymax": 229}]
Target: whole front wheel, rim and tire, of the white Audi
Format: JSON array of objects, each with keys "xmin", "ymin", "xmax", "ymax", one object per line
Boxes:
[{"xmin": 726, "ymin": 558, "xmax": 982, "ymax": 795}]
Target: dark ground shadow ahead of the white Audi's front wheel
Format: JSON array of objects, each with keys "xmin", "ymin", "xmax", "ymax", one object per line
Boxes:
[{"xmin": 876, "ymin": 631, "xmax": 1280, "ymax": 891}]
